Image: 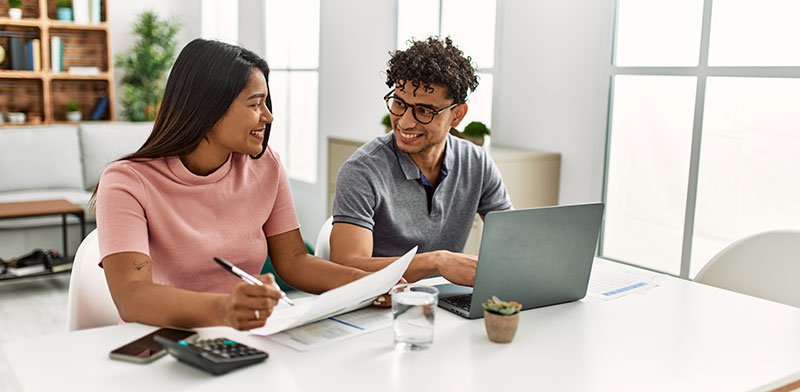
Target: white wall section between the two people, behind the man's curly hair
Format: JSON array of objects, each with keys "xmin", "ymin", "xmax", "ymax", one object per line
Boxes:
[{"xmin": 290, "ymin": 0, "xmax": 395, "ymax": 240}]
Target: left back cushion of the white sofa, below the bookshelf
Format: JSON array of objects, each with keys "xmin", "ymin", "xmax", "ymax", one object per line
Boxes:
[{"xmin": 0, "ymin": 125, "xmax": 84, "ymax": 192}]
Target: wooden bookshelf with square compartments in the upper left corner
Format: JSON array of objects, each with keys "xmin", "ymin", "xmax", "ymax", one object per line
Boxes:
[{"xmin": 0, "ymin": 0, "xmax": 116, "ymax": 126}]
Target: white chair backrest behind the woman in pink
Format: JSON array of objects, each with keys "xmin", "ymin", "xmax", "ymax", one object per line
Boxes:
[{"xmin": 67, "ymin": 229, "xmax": 120, "ymax": 331}]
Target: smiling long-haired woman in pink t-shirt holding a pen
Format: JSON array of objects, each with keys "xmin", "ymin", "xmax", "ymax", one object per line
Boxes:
[{"xmin": 95, "ymin": 39, "xmax": 367, "ymax": 330}]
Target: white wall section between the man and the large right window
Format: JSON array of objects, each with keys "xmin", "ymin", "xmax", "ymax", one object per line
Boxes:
[{"xmin": 492, "ymin": 0, "xmax": 613, "ymax": 204}]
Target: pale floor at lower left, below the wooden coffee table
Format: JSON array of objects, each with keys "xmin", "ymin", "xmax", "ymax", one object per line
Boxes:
[{"xmin": 0, "ymin": 274, "xmax": 69, "ymax": 392}]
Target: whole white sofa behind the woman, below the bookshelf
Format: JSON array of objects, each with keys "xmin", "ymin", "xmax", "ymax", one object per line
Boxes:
[{"xmin": 0, "ymin": 122, "xmax": 153, "ymax": 258}]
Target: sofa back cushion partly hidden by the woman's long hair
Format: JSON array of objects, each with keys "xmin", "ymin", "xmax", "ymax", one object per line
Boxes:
[{"xmin": 80, "ymin": 122, "xmax": 153, "ymax": 191}]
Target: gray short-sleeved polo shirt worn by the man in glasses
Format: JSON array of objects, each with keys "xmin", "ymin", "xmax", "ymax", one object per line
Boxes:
[{"xmin": 333, "ymin": 132, "xmax": 511, "ymax": 257}]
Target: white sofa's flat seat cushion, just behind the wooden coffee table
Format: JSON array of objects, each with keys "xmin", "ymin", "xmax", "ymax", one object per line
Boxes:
[{"xmin": 0, "ymin": 188, "xmax": 94, "ymax": 230}]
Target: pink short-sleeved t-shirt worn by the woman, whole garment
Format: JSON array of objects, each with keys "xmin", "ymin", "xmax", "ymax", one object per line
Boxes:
[{"xmin": 97, "ymin": 149, "xmax": 300, "ymax": 293}]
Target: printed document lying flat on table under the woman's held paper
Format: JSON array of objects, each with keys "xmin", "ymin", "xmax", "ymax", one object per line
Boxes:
[{"xmin": 269, "ymin": 307, "xmax": 392, "ymax": 351}]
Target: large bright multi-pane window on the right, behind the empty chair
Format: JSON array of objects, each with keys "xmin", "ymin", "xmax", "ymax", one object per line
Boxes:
[{"xmin": 600, "ymin": 0, "xmax": 800, "ymax": 278}]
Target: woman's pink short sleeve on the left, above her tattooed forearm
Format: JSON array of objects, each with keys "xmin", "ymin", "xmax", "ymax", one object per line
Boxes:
[{"xmin": 96, "ymin": 163, "xmax": 150, "ymax": 267}]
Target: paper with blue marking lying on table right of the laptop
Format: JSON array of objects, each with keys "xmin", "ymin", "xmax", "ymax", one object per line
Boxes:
[{"xmin": 588, "ymin": 262, "xmax": 664, "ymax": 301}]
